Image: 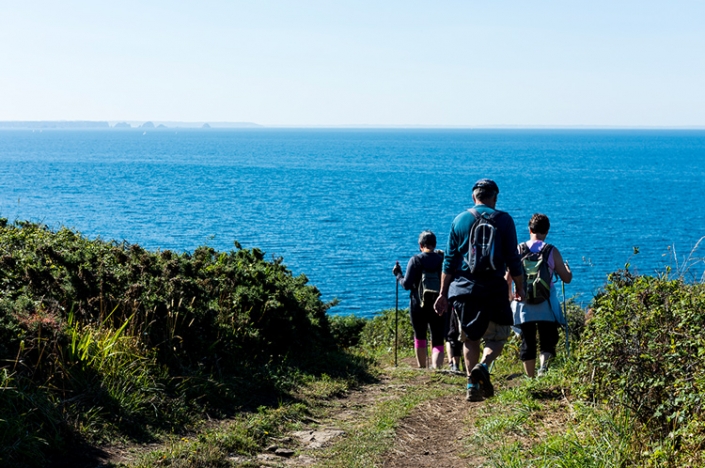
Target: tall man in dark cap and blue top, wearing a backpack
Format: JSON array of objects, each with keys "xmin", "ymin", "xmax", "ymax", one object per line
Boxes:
[{"xmin": 434, "ymin": 179, "xmax": 524, "ymax": 401}]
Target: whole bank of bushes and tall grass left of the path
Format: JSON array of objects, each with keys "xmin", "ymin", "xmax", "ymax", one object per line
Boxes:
[{"xmin": 0, "ymin": 219, "xmax": 366, "ymax": 466}]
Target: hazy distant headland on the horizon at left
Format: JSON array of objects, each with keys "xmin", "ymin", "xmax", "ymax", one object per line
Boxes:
[{"xmin": 0, "ymin": 120, "xmax": 262, "ymax": 130}]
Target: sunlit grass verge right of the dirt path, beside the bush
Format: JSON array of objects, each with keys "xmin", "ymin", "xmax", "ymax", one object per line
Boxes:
[{"xmin": 466, "ymin": 363, "xmax": 634, "ymax": 468}]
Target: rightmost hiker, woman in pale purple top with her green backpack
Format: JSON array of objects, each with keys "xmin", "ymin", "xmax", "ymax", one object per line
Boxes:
[{"xmin": 512, "ymin": 213, "xmax": 573, "ymax": 377}]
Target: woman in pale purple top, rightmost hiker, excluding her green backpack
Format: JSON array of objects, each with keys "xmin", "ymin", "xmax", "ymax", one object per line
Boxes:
[{"xmin": 512, "ymin": 213, "xmax": 573, "ymax": 377}]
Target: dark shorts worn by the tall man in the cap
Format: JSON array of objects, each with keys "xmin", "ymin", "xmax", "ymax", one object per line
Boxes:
[{"xmin": 453, "ymin": 292, "xmax": 513, "ymax": 341}]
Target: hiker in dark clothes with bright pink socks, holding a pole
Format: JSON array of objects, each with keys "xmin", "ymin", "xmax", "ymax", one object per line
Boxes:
[{"xmin": 392, "ymin": 231, "xmax": 444, "ymax": 369}]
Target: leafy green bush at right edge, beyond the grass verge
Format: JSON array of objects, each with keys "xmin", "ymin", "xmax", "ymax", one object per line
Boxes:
[{"xmin": 574, "ymin": 271, "xmax": 705, "ymax": 453}]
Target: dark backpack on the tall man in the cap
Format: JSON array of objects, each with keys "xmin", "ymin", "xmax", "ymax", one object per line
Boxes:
[{"xmin": 465, "ymin": 208, "xmax": 501, "ymax": 276}]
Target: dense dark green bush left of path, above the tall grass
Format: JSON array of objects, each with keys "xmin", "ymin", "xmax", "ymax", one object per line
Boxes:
[{"xmin": 0, "ymin": 219, "xmax": 330, "ymax": 372}]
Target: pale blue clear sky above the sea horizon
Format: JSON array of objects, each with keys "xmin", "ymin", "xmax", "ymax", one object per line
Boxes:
[{"xmin": 0, "ymin": 0, "xmax": 705, "ymax": 127}]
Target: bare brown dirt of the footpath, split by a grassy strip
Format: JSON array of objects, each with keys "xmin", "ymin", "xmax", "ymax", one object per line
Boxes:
[{"xmin": 69, "ymin": 359, "xmax": 484, "ymax": 468}]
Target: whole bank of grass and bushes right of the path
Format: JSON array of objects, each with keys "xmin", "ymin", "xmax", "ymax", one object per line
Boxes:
[{"xmin": 466, "ymin": 270, "xmax": 705, "ymax": 468}]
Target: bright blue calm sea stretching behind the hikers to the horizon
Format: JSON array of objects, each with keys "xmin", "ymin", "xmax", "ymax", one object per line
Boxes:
[{"xmin": 0, "ymin": 129, "xmax": 705, "ymax": 316}]
